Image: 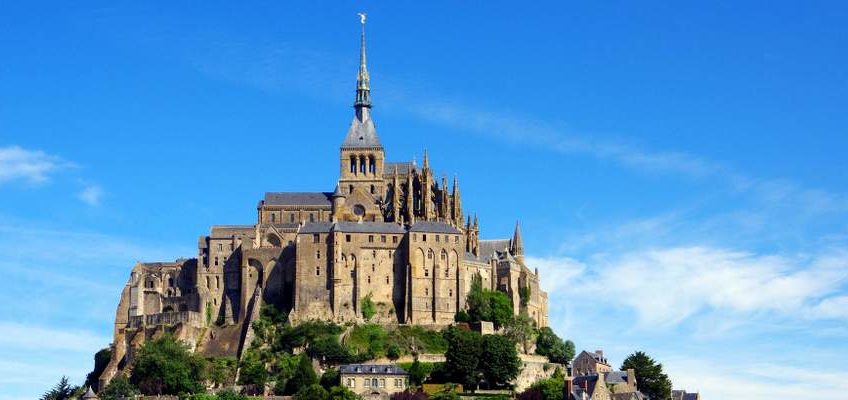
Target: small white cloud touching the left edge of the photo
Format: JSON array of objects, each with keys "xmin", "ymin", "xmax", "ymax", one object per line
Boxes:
[{"xmin": 0, "ymin": 146, "xmax": 70, "ymax": 184}]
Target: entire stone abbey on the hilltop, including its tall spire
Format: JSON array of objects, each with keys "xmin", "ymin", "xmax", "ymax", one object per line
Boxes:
[{"xmin": 101, "ymin": 18, "xmax": 548, "ymax": 387}]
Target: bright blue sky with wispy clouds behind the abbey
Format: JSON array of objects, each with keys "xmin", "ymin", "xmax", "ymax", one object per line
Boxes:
[{"xmin": 0, "ymin": 1, "xmax": 848, "ymax": 399}]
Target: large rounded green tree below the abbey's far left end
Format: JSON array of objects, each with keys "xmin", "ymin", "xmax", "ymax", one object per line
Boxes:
[{"xmin": 130, "ymin": 335, "xmax": 205, "ymax": 394}]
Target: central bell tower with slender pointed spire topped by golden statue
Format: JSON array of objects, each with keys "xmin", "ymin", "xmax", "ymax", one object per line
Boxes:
[{"xmin": 339, "ymin": 13, "xmax": 385, "ymax": 221}]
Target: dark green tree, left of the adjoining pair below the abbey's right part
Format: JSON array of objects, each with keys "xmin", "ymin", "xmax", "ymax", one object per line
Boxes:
[{"xmin": 445, "ymin": 327, "xmax": 482, "ymax": 390}]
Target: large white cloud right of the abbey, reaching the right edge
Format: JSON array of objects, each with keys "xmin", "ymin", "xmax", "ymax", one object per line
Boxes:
[{"xmin": 531, "ymin": 247, "xmax": 848, "ymax": 328}]
